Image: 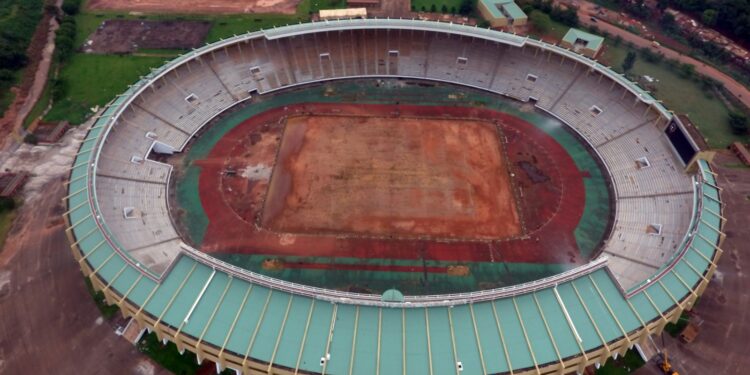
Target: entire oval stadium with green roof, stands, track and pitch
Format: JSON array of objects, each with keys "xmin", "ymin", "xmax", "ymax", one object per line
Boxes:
[{"xmin": 65, "ymin": 19, "xmax": 725, "ymax": 374}]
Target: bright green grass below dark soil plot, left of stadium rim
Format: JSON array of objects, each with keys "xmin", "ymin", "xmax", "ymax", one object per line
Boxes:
[{"xmin": 44, "ymin": 53, "xmax": 165, "ymax": 125}]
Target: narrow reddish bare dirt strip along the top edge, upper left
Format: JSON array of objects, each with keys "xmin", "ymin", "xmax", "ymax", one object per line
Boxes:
[{"xmin": 87, "ymin": 0, "xmax": 301, "ymax": 14}]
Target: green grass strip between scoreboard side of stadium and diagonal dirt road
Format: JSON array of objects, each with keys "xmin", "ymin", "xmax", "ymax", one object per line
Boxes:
[{"xmin": 601, "ymin": 43, "xmax": 750, "ymax": 148}]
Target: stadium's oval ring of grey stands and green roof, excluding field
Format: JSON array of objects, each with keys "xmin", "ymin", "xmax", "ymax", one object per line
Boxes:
[{"xmin": 65, "ymin": 20, "xmax": 724, "ymax": 374}]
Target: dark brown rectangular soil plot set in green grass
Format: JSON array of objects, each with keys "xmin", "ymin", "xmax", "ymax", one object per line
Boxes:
[{"xmin": 83, "ymin": 20, "xmax": 211, "ymax": 53}]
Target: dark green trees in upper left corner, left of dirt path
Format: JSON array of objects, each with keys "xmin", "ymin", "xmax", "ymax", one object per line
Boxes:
[{"xmin": 0, "ymin": 0, "xmax": 44, "ymax": 108}]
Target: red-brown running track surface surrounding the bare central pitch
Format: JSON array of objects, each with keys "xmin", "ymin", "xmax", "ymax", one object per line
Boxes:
[{"xmin": 194, "ymin": 104, "xmax": 587, "ymax": 263}]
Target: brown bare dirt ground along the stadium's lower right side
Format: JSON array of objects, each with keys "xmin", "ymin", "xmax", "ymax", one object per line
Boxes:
[{"xmin": 636, "ymin": 151, "xmax": 750, "ymax": 375}]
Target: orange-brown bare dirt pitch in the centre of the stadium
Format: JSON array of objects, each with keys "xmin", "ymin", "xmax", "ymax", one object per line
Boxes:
[{"xmin": 262, "ymin": 115, "xmax": 521, "ymax": 239}]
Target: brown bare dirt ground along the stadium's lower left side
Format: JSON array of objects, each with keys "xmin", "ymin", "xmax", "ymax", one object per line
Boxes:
[{"xmin": 0, "ymin": 122, "xmax": 166, "ymax": 375}]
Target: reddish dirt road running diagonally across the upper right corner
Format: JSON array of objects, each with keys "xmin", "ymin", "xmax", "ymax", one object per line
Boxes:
[{"xmin": 578, "ymin": 0, "xmax": 750, "ymax": 108}]
